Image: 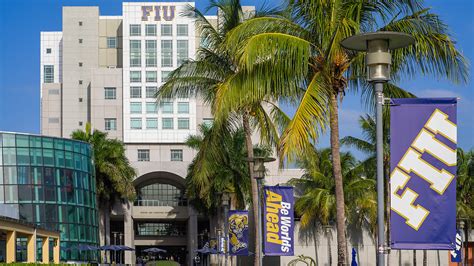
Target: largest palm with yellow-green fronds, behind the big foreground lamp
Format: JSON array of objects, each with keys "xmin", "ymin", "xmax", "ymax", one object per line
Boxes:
[{"xmin": 221, "ymin": 0, "xmax": 468, "ymax": 265}]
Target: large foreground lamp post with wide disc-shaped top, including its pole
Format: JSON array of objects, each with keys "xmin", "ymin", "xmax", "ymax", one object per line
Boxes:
[{"xmin": 341, "ymin": 31, "xmax": 415, "ymax": 266}]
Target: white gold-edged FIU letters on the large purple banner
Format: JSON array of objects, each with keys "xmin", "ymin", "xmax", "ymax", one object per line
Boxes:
[{"xmin": 390, "ymin": 109, "xmax": 457, "ymax": 230}]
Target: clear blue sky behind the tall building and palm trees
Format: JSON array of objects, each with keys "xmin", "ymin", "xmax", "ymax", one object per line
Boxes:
[{"xmin": 0, "ymin": 0, "xmax": 474, "ymax": 157}]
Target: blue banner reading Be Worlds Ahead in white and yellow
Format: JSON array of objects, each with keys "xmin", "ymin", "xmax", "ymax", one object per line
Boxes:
[{"xmin": 263, "ymin": 186, "xmax": 295, "ymax": 256}]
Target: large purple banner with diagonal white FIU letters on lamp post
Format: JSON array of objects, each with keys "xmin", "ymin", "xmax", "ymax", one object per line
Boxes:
[{"xmin": 390, "ymin": 98, "xmax": 457, "ymax": 250}]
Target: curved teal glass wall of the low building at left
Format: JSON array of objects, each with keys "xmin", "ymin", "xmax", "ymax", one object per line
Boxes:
[{"xmin": 0, "ymin": 132, "xmax": 99, "ymax": 260}]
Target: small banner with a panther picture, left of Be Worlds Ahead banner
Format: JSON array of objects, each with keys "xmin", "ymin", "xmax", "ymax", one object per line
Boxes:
[{"xmin": 229, "ymin": 210, "xmax": 249, "ymax": 256}]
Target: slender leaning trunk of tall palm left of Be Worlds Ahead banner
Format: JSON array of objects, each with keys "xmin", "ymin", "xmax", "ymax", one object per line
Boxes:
[{"xmin": 242, "ymin": 111, "xmax": 262, "ymax": 266}]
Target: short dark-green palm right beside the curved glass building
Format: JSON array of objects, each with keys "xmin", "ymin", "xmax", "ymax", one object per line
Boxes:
[{"xmin": 71, "ymin": 123, "xmax": 136, "ymax": 248}]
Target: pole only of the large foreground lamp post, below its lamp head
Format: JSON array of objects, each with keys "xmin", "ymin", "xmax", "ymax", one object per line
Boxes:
[{"xmin": 374, "ymin": 82, "xmax": 385, "ymax": 266}]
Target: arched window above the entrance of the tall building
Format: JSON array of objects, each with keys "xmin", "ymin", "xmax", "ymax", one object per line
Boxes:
[{"xmin": 135, "ymin": 183, "xmax": 186, "ymax": 207}]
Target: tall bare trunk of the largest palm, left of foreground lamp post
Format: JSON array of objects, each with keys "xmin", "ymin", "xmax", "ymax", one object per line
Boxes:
[{"xmin": 329, "ymin": 92, "xmax": 346, "ymax": 266}]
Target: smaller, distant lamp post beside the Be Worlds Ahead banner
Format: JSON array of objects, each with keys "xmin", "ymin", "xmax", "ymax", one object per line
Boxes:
[{"xmin": 249, "ymin": 157, "xmax": 275, "ymax": 266}]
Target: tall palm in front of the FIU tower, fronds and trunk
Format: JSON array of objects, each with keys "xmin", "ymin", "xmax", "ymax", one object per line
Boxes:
[{"xmin": 157, "ymin": 0, "xmax": 288, "ymax": 265}]
